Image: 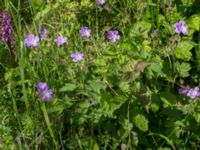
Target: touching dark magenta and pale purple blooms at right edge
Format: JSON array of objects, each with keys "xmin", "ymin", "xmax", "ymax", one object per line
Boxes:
[{"xmin": 179, "ymin": 87, "xmax": 200, "ymax": 99}]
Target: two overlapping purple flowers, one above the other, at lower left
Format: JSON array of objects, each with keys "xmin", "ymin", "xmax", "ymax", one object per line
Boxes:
[{"xmin": 37, "ymin": 82, "xmax": 53, "ymax": 101}]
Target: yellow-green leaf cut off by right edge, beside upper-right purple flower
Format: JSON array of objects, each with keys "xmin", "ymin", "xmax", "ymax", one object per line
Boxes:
[{"xmin": 187, "ymin": 14, "xmax": 200, "ymax": 31}]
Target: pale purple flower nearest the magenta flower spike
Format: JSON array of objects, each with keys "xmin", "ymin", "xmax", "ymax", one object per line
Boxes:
[{"xmin": 24, "ymin": 34, "xmax": 39, "ymax": 47}]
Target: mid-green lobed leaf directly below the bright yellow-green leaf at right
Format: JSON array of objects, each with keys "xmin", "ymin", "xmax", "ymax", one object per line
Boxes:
[{"xmin": 175, "ymin": 62, "xmax": 191, "ymax": 77}]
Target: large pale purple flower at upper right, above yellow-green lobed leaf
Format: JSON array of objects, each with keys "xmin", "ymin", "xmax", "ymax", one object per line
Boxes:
[{"xmin": 174, "ymin": 20, "xmax": 188, "ymax": 35}]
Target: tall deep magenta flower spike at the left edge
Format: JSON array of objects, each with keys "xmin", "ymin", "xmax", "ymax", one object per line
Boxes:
[{"xmin": 0, "ymin": 11, "xmax": 13, "ymax": 43}]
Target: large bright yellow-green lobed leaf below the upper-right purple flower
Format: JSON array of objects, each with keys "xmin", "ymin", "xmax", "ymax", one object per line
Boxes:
[{"xmin": 175, "ymin": 41, "xmax": 194, "ymax": 61}]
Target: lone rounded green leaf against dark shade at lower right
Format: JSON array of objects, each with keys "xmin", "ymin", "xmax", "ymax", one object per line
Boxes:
[{"xmin": 133, "ymin": 114, "xmax": 149, "ymax": 132}]
